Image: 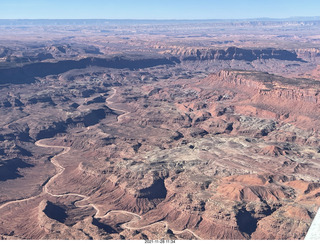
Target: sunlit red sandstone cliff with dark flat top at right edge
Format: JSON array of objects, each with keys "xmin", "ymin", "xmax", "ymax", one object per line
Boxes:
[{"xmin": 204, "ymin": 70, "xmax": 320, "ymax": 117}]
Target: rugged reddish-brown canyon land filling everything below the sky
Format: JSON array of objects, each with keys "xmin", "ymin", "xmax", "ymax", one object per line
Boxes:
[{"xmin": 0, "ymin": 20, "xmax": 320, "ymax": 240}]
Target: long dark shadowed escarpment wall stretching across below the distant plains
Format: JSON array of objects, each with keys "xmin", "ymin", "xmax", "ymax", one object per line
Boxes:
[{"xmin": 0, "ymin": 47, "xmax": 306, "ymax": 84}]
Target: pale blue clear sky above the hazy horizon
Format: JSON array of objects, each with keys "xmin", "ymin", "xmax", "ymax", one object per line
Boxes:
[{"xmin": 0, "ymin": 0, "xmax": 320, "ymax": 19}]
